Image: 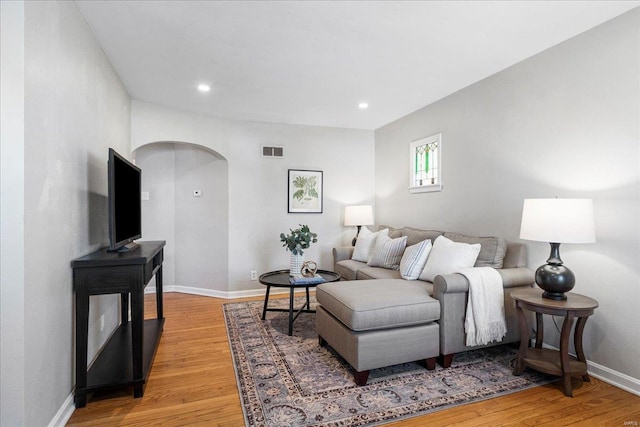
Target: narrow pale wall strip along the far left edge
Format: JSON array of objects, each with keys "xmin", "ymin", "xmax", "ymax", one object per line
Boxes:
[{"xmin": 0, "ymin": 2, "xmax": 25, "ymax": 425}]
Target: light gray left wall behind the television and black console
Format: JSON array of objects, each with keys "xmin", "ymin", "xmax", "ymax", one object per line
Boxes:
[{"xmin": 0, "ymin": 1, "xmax": 131, "ymax": 426}]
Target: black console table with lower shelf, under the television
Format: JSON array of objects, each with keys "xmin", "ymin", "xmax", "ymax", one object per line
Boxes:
[{"xmin": 71, "ymin": 241, "xmax": 165, "ymax": 408}]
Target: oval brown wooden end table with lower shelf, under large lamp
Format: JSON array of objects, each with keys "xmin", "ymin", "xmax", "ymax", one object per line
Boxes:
[{"xmin": 511, "ymin": 288, "xmax": 598, "ymax": 397}]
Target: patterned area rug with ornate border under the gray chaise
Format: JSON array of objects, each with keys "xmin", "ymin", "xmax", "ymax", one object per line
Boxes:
[{"xmin": 224, "ymin": 298, "xmax": 555, "ymax": 426}]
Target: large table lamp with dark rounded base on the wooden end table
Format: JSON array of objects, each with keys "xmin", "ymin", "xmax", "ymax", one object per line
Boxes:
[{"xmin": 520, "ymin": 199, "xmax": 596, "ymax": 301}]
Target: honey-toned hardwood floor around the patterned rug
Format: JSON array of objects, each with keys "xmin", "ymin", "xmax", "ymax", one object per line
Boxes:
[{"xmin": 68, "ymin": 293, "xmax": 640, "ymax": 426}]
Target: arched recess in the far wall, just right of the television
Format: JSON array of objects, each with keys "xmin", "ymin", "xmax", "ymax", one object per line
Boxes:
[{"xmin": 135, "ymin": 142, "xmax": 229, "ymax": 292}]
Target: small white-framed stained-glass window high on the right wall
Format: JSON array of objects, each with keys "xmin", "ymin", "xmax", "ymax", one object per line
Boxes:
[{"xmin": 409, "ymin": 134, "xmax": 442, "ymax": 193}]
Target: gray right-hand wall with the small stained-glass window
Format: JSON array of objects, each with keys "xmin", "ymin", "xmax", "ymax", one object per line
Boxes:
[{"xmin": 375, "ymin": 9, "xmax": 640, "ymax": 384}]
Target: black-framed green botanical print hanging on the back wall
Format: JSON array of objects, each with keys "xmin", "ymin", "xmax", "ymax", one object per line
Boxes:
[{"xmin": 288, "ymin": 169, "xmax": 322, "ymax": 213}]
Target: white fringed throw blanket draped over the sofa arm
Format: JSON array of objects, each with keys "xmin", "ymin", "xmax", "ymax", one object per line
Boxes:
[{"xmin": 459, "ymin": 267, "xmax": 507, "ymax": 346}]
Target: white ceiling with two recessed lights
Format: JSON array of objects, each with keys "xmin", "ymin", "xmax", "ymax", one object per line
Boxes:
[{"xmin": 76, "ymin": 0, "xmax": 640, "ymax": 129}]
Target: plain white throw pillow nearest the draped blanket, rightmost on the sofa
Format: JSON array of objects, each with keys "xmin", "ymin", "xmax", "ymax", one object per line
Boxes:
[{"xmin": 420, "ymin": 236, "xmax": 481, "ymax": 282}]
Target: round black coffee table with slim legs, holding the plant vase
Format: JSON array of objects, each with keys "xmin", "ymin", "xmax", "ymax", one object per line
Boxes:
[{"xmin": 258, "ymin": 270, "xmax": 340, "ymax": 336}]
